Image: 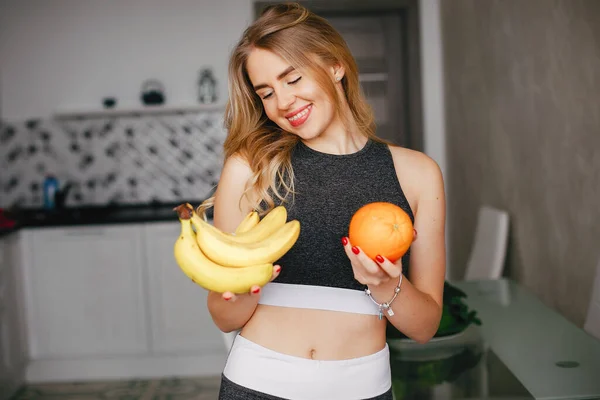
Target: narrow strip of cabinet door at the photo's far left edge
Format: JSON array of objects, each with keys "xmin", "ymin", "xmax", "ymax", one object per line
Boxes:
[{"xmin": 0, "ymin": 233, "xmax": 27, "ymax": 400}]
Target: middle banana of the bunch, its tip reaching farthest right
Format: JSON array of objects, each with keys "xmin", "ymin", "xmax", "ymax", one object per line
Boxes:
[{"xmin": 196, "ymin": 211, "xmax": 300, "ymax": 267}]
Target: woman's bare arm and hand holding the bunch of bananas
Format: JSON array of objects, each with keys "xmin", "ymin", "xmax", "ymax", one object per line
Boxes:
[{"xmin": 207, "ymin": 157, "xmax": 278, "ymax": 332}]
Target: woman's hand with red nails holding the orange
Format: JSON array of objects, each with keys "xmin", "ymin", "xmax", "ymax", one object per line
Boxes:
[{"xmin": 342, "ymin": 231, "xmax": 417, "ymax": 287}]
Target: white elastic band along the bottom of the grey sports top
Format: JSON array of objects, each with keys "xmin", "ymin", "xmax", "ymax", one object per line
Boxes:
[{"xmin": 258, "ymin": 282, "xmax": 379, "ymax": 315}]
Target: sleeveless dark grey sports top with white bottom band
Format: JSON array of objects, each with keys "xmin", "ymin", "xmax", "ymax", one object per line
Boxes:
[{"xmin": 259, "ymin": 139, "xmax": 414, "ymax": 314}]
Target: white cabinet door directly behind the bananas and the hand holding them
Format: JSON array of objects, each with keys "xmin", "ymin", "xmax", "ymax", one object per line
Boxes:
[{"xmin": 145, "ymin": 221, "xmax": 226, "ymax": 355}]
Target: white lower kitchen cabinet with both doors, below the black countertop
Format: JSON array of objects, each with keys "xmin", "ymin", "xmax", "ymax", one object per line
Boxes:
[{"xmin": 21, "ymin": 221, "xmax": 227, "ymax": 382}]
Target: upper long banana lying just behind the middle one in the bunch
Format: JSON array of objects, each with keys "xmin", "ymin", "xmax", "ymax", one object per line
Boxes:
[{"xmin": 186, "ymin": 204, "xmax": 287, "ymax": 244}]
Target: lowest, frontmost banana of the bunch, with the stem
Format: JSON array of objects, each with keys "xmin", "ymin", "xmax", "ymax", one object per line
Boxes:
[{"xmin": 174, "ymin": 206, "xmax": 273, "ymax": 294}]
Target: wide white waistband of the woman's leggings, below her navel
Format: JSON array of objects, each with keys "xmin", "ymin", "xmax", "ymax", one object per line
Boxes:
[{"xmin": 223, "ymin": 335, "xmax": 392, "ymax": 400}]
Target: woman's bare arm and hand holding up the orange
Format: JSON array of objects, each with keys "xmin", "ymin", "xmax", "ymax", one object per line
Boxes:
[{"xmin": 345, "ymin": 153, "xmax": 446, "ymax": 343}]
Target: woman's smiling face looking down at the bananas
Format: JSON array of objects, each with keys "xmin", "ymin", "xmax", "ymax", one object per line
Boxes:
[{"xmin": 246, "ymin": 48, "xmax": 344, "ymax": 141}]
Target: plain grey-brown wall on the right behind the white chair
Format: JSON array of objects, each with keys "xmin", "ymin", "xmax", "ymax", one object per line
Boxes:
[{"xmin": 442, "ymin": 0, "xmax": 600, "ymax": 325}]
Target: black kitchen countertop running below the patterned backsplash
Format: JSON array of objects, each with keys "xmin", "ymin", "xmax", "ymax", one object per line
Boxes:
[{"xmin": 0, "ymin": 200, "xmax": 212, "ymax": 237}]
